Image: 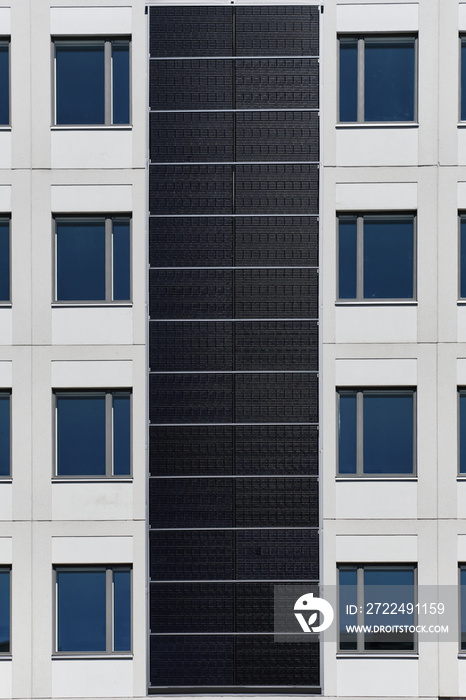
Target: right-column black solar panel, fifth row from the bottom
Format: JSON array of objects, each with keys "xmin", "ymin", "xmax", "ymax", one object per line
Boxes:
[{"xmin": 235, "ymin": 425, "xmax": 318, "ymax": 475}]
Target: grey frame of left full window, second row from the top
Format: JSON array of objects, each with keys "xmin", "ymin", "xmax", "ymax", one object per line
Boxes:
[{"xmin": 53, "ymin": 213, "xmax": 133, "ymax": 306}]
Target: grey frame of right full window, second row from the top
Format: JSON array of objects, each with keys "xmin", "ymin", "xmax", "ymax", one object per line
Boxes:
[{"xmin": 336, "ymin": 211, "xmax": 417, "ymax": 304}]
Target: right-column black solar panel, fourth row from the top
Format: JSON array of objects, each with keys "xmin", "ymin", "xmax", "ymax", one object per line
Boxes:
[{"xmin": 235, "ymin": 164, "xmax": 319, "ymax": 214}]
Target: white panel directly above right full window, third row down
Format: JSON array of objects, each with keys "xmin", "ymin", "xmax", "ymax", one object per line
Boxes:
[{"xmin": 335, "ymin": 359, "xmax": 417, "ymax": 386}]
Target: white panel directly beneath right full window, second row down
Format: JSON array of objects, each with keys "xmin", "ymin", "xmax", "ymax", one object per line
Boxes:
[{"xmin": 335, "ymin": 305, "xmax": 418, "ymax": 343}]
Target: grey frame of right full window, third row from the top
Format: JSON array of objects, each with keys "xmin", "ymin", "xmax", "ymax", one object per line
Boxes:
[{"xmin": 335, "ymin": 386, "xmax": 417, "ymax": 480}]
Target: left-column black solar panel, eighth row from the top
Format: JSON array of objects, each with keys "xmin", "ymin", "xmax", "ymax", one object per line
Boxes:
[{"xmin": 149, "ymin": 374, "xmax": 233, "ymax": 423}]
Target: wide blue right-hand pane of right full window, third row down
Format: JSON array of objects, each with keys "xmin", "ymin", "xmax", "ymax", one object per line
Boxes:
[{"xmin": 363, "ymin": 394, "xmax": 414, "ymax": 474}]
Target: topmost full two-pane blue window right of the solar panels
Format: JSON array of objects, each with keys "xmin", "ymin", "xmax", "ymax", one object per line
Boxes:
[{"xmin": 339, "ymin": 36, "xmax": 416, "ymax": 122}]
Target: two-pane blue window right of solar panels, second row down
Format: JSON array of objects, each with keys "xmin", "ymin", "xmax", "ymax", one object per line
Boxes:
[{"xmin": 338, "ymin": 214, "xmax": 415, "ymax": 300}]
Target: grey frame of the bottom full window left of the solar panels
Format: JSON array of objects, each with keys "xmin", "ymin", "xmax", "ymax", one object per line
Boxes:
[{"xmin": 53, "ymin": 564, "xmax": 134, "ymax": 657}]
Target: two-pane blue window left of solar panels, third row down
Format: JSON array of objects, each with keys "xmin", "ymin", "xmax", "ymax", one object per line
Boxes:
[{"xmin": 56, "ymin": 391, "xmax": 131, "ymax": 477}]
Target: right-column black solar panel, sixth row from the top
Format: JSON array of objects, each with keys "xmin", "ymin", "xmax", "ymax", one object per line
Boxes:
[{"xmin": 235, "ymin": 268, "xmax": 318, "ymax": 319}]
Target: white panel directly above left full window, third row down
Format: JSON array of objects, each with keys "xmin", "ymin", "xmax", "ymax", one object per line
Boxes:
[{"xmin": 52, "ymin": 360, "xmax": 133, "ymax": 389}]
